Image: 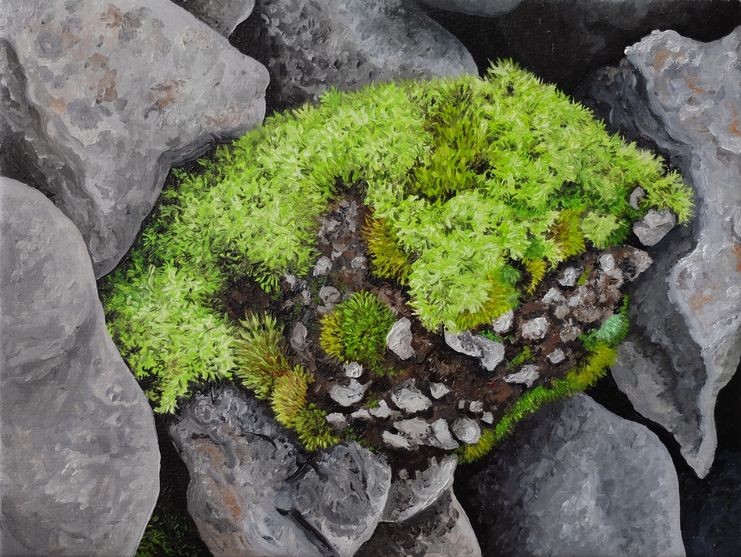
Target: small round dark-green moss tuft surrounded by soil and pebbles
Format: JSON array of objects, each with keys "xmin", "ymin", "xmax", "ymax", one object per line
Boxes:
[{"xmin": 320, "ymin": 292, "xmax": 396, "ymax": 375}]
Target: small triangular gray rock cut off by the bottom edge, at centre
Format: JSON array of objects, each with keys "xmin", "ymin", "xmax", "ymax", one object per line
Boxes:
[{"xmin": 357, "ymin": 488, "xmax": 481, "ymax": 557}]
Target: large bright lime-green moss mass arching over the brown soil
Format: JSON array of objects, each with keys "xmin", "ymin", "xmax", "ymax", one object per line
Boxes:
[{"xmin": 105, "ymin": 62, "xmax": 692, "ymax": 412}]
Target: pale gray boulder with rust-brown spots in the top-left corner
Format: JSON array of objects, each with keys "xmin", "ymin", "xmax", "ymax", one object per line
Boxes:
[{"xmin": 0, "ymin": 0, "xmax": 268, "ymax": 277}]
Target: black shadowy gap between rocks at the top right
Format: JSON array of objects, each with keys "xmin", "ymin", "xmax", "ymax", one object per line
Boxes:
[{"xmin": 425, "ymin": 0, "xmax": 741, "ymax": 93}]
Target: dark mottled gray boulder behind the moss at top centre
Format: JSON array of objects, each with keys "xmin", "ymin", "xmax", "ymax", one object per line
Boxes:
[{"xmin": 232, "ymin": 0, "xmax": 477, "ymax": 108}]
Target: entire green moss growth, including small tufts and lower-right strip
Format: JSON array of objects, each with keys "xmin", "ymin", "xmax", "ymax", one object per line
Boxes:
[{"xmin": 104, "ymin": 61, "xmax": 692, "ymax": 460}]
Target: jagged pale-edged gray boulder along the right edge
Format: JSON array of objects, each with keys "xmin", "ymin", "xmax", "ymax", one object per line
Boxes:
[{"xmin": 581, "ymin": 28, "xmax": 741, "ymax": 477}]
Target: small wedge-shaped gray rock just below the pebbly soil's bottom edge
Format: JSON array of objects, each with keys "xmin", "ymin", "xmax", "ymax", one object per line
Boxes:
[{"xmin": 381, "ymin": 456, "xmax": 458, "ymax": 522}]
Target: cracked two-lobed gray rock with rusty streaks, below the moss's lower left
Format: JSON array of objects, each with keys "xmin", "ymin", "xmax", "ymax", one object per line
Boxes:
[{"xmin": 170, "ymin": 387, "xmax": 391, "ymax": 557}]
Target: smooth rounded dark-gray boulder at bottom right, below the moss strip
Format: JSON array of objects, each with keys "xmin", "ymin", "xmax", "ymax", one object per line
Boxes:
[{"xmin": 465, "ymin": 395, "xmax": 684, "ymax": 557}]
